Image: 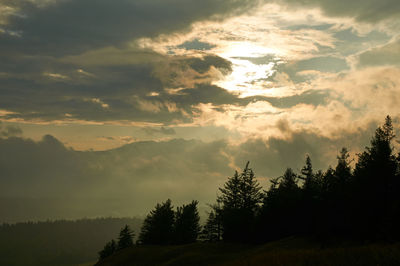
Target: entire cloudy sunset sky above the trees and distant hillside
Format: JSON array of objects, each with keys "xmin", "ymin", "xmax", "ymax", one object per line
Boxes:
[{"xmin": 0, "ymin": 0, "xmax": 400, "ymax": 221}]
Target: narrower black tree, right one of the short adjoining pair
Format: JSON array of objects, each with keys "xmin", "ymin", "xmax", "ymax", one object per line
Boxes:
[{"xmin": 174, "ymin": 200, "xmax": 200, "ymax": 244}]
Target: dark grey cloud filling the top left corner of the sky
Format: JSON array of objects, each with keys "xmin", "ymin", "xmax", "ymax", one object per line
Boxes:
[{"xmin": 0, "ymin": 0, "xmax": 255, "ymax": 56}]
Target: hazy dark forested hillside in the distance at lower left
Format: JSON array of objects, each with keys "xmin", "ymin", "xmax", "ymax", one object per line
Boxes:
[{"xmin": 0, "ymin": 218, "xmax": 142, "ymax": 266}]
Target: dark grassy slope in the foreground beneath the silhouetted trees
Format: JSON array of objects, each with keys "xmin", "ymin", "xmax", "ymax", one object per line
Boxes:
[{"xmin": 97, "ymin": 238, "xmax": 400, "ymax": 266}]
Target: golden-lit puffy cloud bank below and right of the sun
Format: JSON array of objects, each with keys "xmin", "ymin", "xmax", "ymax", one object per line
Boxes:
[{"xmin": 188, "ymin": 63, "xmax": 400, "ymax": 141}]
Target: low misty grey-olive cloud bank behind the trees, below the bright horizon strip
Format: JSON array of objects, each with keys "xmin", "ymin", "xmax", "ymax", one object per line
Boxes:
[{"xmin": 0, "ymin": 125, "xmax": 384, "ymax": 221}]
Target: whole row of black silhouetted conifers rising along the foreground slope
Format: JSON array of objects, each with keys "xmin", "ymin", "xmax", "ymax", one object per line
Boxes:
[{"xmin": 98, "ymin": 116, "xmax": 400, "ymax": 260}]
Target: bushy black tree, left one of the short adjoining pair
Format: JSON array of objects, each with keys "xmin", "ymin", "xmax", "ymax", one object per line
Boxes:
[{"xmin": 139, "ymin": 199, "xmax": 175, "ymax": 244}]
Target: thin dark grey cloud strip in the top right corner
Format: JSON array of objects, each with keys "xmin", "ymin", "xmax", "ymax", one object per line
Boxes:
[{"xmin": 275, "ymin": 0, "xmax": 400, "ymax": 23}]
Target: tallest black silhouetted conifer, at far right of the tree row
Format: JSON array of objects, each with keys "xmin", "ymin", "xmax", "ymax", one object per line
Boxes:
[{"xmin": 353, "ymin": 116, "xmax": 399, "ymax": 238}]
